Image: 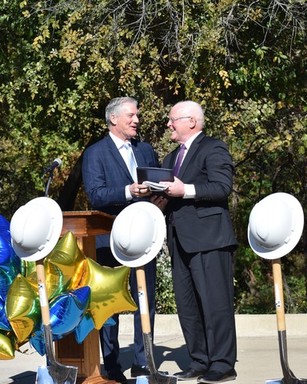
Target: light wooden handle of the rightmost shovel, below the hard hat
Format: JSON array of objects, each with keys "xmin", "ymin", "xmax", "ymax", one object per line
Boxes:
[{"xmin": 272, "ymin": 259, "xmax": 286, "ymax": 331}]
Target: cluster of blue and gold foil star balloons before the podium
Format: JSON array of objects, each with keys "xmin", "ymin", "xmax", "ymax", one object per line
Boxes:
[{"xmin": 0, "ymin": 215, "xmax": 137, "ymax": 360}]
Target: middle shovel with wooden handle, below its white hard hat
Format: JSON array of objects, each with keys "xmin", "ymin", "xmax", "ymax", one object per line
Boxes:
[{"xmin": 136, "ymin": 266, "xmax": 177, "ymax": 384}]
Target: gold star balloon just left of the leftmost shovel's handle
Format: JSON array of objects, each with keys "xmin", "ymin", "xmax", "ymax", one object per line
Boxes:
[{"xmin": 5, "ymin": 274, "xmax": 41, "ymax": 343}]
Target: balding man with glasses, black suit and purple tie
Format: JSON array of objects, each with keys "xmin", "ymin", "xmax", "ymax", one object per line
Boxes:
[{"xmin": 163, "ymin": 101, "xmax": 237, "ymax": 383}]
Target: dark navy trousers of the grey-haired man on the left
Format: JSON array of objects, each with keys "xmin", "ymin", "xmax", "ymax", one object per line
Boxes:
[{"xmin": 96, "ymin": 243, "xmax": 156, "ymax": 372}]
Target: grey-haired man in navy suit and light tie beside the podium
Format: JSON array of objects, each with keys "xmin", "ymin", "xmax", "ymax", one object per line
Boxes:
[{"xmin": 82, "ymin": 97, "xmax": 159, "ymax": 383}]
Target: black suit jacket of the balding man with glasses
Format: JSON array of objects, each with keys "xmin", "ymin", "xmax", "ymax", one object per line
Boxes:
[{"xmin": 162, "ymin": 132, "xmax": 237, "ymax": 253}]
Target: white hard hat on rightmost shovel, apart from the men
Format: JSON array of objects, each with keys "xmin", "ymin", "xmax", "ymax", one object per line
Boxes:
[{"xmin": 247, "ymin": 192, "xmax": 304, "ymax": 260}]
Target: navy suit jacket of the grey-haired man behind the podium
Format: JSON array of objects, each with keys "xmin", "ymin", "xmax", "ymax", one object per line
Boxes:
[{"xmin": 82, "ymin": 135, "xmax": 159, "ymax": 215}]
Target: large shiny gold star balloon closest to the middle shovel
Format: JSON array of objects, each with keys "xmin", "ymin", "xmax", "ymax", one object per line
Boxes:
[{"xmin": 71, "ymin": 258, "xmax": 137, "ymax": 329}]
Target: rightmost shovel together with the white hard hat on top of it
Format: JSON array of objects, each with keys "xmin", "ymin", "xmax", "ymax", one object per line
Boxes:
[{"xmin": 247, "ymin": 192, "xmax": 307, "ymax": 384}]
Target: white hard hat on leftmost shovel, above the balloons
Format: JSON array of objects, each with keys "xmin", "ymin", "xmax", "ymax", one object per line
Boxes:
[{"xmin": 10, "ymin": 197, "xmax": 63, "ymax": 261}]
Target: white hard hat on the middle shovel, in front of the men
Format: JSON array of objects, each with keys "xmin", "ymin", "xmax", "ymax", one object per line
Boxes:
[{"xmin": 110, "ymin": 201, "xmax": 166, "ymax": 267}]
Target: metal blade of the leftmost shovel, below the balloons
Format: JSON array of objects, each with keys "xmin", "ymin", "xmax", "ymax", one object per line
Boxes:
[{"xmin": 35, "ymin": 364, "xmax": 78, "ymax": 384}]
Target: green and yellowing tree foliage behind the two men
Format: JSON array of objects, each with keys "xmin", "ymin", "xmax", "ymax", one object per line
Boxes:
[{"xmin": 0, "ymin": 0, "xmax": 307, "ymax": 312}]
